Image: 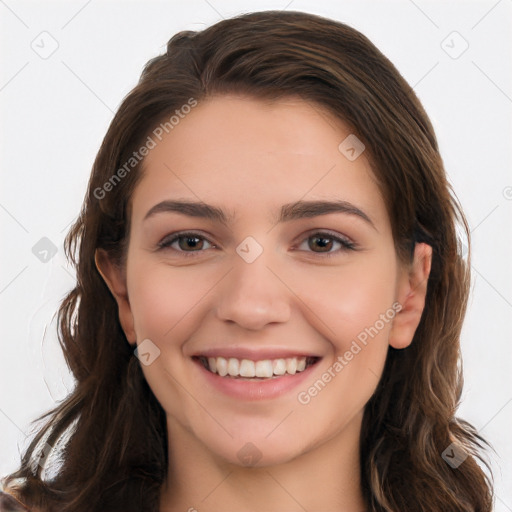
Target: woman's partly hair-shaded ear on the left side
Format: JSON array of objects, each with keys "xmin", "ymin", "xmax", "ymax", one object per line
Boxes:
[{"xmin": 94, "ymin": 249, "xmax": 137, "ymax": 345}]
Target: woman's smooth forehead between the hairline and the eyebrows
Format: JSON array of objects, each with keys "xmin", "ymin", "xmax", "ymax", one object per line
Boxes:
[{"xmin": 133, "ymin": 96, "xmax": 385, "ymax": 230}]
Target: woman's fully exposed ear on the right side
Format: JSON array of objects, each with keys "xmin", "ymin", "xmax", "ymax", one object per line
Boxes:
[{"xmin": 389, "ymin": 243, "xmax": 432, "ymax": 348}]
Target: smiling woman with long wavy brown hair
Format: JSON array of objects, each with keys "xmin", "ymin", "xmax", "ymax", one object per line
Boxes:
[{"xmin": 4, "ymin": 11, "xmax": 492, "ymax": 512}]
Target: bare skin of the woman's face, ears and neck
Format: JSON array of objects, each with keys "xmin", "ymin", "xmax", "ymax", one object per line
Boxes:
[{"xmin": 96, "ymin": 96, "xmax": 431, "ymax": 512}]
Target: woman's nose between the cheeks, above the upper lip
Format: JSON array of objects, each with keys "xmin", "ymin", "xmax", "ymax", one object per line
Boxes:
[{"xmin": 216, "ymin": 245, "xmax": 293, "ymax": 330}]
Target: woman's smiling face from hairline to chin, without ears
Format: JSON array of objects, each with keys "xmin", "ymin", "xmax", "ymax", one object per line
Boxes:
[{"xmin": 108, "ymin": 96, "xmax": 412, "ymax": 465}]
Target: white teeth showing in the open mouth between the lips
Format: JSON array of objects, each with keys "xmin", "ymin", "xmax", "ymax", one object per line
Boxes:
[{"xmin": 193, "ymin": 356, "xmax": 320, "ymax": 380}]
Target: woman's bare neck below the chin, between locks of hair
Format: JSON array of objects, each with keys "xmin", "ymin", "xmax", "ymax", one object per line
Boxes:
[{"xmin": 160, "ymin": 416, "xmax": 366, "ymax": 512}]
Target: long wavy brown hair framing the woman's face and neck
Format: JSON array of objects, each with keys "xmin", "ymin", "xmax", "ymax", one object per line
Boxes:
[{"xmin": 2, "ymin": 11, "xmax": 492, "ymax": 512}]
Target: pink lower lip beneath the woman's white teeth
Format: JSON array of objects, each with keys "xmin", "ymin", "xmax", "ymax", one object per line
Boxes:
[{"xmin": 193, "ymin": 359, "xmax": 319, "ymax": 401}]
